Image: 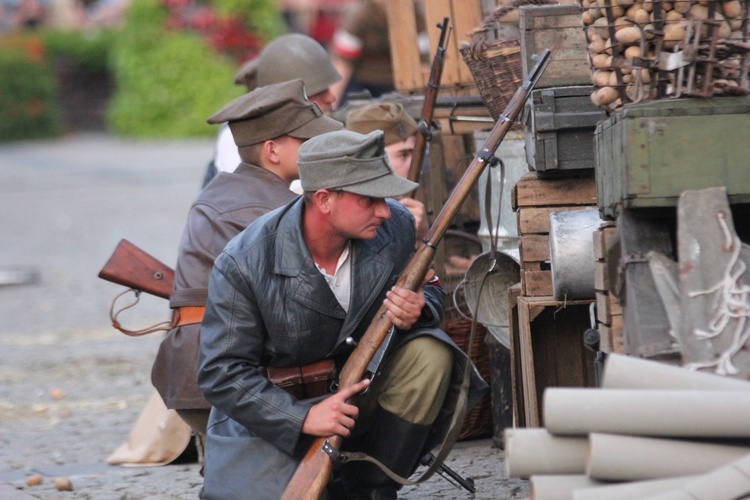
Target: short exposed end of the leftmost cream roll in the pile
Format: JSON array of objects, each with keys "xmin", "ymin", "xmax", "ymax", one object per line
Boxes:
[{"xmin": 505, "ymin": 428, "xmax": 588, "ymax": 478}]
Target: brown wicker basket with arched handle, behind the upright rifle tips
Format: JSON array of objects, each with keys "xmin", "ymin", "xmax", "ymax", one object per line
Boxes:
[{"xmin": 459, "ymin": 0, "xmax": 557, "ymax": 121}]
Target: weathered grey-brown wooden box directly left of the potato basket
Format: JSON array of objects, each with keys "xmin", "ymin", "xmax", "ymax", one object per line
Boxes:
[{"xmin": 518, "ymin": 3, "xmax": 591, "ymax": 89}]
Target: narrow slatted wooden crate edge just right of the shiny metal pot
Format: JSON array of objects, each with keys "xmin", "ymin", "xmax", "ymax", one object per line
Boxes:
[{"xmin": 594, "ymin": 222, "xmax": 625, "ymax": 354}]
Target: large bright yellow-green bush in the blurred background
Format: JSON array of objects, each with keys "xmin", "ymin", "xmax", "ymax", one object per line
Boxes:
[{"xmin": 108, "ymin": 0, "xmax": 242, "ymax": 137}]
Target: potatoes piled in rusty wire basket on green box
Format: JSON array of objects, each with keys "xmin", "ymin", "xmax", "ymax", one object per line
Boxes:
[{"xmin": 581, "ymin": 0, "xmax": 750, "ymax": 110}]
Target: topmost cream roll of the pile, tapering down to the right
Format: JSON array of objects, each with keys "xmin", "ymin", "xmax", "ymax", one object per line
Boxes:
[{"xmin": 601, "ymin": 353, "xmax": 750, "ymax": 391}]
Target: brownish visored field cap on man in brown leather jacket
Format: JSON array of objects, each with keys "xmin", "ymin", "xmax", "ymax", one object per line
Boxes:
[{"xmin": 206, "ymin": 78, "xmax": 342, "ymax": 146}]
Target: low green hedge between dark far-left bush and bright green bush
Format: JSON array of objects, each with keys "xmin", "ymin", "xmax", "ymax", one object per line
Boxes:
[{"xmin": 41, "ymin": 29, "xmax": 117, "ymax": 73}]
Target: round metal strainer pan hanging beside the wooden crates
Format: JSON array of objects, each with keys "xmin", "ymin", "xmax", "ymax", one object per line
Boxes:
[{"xmin": 453, "ymin": 252, "xmax": 521, "ymax": 348}]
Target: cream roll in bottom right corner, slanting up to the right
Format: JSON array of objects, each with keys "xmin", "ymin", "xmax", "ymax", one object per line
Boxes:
[{"xmin": 646, "ymin": 455, "xmax": 750, "ymax": 500}]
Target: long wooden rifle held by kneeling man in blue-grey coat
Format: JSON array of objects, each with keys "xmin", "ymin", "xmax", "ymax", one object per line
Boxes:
[{"xmin": 282, "ymin": 49, "xmax": 550, "ymax": 500}]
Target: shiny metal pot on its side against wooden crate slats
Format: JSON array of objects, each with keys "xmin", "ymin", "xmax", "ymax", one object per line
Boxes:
[{"xmin": 549, "ymin": 209, "xmax": 602, "ymax": 300}]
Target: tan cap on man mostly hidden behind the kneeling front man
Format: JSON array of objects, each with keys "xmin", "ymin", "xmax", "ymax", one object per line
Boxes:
[{"xmin": 346, "ymin": 102, "xmax": 417, "ymax": 146}]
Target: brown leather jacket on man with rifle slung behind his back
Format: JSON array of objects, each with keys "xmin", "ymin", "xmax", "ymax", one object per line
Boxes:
[{"xmin": 151, "ymin": 163, "xmax": 297, "ymax": 410}]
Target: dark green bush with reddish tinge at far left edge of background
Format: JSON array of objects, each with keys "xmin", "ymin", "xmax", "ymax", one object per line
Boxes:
[{"xmin": 0, "ymin": 47, "xmax": 61, "ymax": 141}]
